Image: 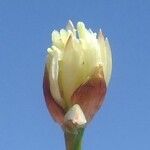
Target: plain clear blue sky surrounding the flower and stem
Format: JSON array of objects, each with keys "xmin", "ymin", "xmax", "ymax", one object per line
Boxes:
[{"xmin": 0, "ymin": 0, "xmax": 150, "ymax": 150}]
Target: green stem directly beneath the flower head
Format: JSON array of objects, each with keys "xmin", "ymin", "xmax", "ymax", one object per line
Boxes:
[{"xmin": 64, "ymin": 128, "xmax": 84, "ymax": 150}]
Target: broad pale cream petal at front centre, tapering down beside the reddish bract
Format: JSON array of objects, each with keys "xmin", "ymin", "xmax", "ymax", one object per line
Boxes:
[{"xmin": 61, "ymin": 42, "xmax": 86, "ymax": 106}]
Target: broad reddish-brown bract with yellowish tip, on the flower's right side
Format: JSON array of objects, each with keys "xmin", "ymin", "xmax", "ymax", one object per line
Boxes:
[{"xmin": 72, "ymin": 68, "xmax": 106, "ymax": 122}]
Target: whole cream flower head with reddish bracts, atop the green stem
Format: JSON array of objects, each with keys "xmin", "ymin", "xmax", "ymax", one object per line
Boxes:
[{"xmin": 43, "ymin": 21, "xmax": 112, "ymax": 127}]
